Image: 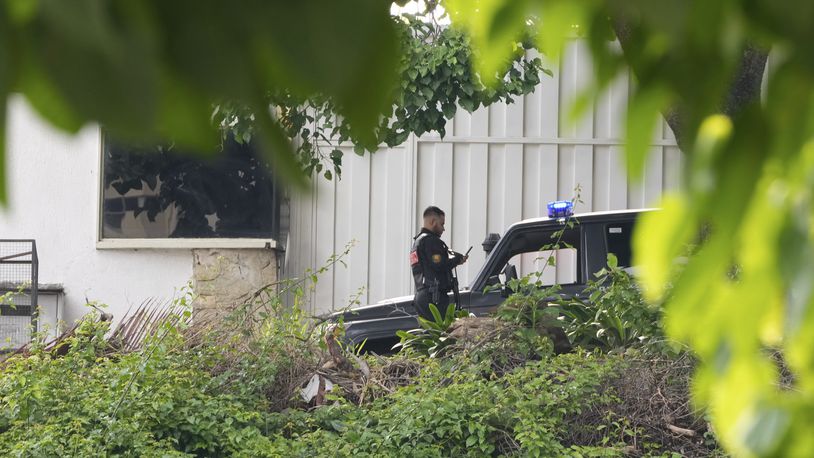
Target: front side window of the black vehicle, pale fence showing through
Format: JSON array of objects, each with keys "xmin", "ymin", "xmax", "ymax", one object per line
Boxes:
[{"xmin": 500, "ymin": 226, "xmax": 580, "ymax": 286}]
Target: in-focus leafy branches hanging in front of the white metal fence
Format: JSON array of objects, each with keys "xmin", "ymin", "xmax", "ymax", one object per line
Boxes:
[{"xmin": 210, "ymin": 14, "xmax": 551, "ymax": 180}]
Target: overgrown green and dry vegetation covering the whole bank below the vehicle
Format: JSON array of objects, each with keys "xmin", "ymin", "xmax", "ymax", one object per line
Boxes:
[{"xmin": 0, "ymin": 256, "xmax": 720, "ymax": 457}]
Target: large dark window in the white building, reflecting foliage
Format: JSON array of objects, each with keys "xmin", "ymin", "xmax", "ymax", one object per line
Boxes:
[{"xmin": 102, "ymin": 134, "xmax": 280, "ymax": 239}]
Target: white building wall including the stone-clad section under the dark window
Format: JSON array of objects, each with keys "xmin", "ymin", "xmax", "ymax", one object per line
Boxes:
[{"xmin": 0, "ymin": 98, "xmax": 279, "ymax": 337}]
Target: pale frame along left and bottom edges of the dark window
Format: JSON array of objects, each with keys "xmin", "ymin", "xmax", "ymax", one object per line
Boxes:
[{"xmin": 94, "ymin": 127, "xmax": 282, "ymax": 250}]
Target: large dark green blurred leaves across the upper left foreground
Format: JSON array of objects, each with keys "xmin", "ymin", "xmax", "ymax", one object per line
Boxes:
[{"xmin": 0, "ymin": 0, "xmax": 399, "ymax": 197}]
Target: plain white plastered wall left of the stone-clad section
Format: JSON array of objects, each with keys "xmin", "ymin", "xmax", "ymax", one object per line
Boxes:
[{"xmin": 0, "ymin": 98, "xmax": 192, "ymax": 323}]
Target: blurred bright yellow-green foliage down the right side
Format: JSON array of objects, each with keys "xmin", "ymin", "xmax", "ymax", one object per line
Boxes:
[{"xmin": 445, "ymin": 0, "xmax": 814, "ymax": 456}]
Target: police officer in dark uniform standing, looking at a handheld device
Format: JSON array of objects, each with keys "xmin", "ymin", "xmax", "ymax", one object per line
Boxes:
[{"xmin": 410, "ymin": 206, "xmax": 469, "ymax": 320}]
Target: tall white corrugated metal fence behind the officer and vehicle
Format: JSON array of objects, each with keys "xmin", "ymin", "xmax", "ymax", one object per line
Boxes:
[{"xmin": 286, "ymin": 41, "xmax": 682, "ymax": 312}]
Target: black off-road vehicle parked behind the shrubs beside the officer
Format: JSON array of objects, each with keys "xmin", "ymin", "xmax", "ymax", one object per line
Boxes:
[{"xmin": 333, "ymin": 209, "xmax": 653, "ymax": 353}]
